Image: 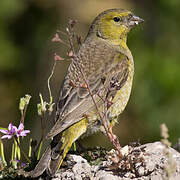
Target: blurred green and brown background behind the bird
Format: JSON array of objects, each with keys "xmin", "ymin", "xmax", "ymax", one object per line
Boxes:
[{"xmin": 0, "ymin": 0, "xmax": 180, "ymax": 155}]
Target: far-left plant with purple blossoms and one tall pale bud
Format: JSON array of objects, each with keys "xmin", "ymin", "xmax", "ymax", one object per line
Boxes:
[{"xmin": 0, "ymin": 95, "xmax": 31, "ymax": 178}]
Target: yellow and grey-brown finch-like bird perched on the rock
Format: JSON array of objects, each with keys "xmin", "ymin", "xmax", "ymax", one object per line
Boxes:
[{"xmin": 30, "ymin": 8, "xmax": 144, "ymax": 177}]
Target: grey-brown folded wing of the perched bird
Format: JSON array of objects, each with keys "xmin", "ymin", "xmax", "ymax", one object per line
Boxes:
[{"xmin": 47, "ymin": 41, "xmax": 128, "ymax": 138}]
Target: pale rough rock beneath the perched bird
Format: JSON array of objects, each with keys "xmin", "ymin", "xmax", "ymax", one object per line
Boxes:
[{"xmin": 52, "ymin": 142, "xmax": 180, "ymax": 180}]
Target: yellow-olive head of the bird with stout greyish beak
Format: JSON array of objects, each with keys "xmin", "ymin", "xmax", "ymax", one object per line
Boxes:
[{"xmin": 89, "ymin": 9, "xmax": 144, "ymax": 43}]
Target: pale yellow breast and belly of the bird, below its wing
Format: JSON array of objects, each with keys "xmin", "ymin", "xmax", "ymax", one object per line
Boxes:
[{"xmin": 86, "ymin": 52, "xmax": 134, "ymax": 135}]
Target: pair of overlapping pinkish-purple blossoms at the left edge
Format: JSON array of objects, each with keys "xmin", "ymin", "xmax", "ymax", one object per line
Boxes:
[{"xmin": 0, "ymin": 123, "xmax": 30, "ymax": 139}]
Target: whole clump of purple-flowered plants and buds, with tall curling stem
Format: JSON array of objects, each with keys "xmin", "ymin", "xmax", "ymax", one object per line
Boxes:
[{"xmin": 0, "ymin": 57, "xmax": 57, "ymax": 179}]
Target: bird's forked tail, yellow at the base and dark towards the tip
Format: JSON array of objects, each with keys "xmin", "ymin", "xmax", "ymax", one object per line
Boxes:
[{"xmin": 30, "ymin": 118, "xmax": 88, "ymax": 177}]
